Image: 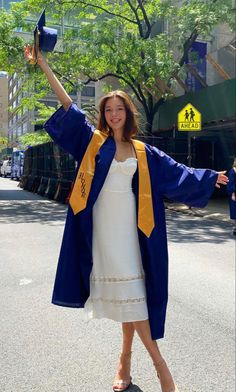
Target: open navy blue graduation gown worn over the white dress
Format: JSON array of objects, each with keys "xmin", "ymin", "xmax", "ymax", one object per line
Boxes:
[{"xmin": 45, "ymin": 104, "xmax": 217, "ymax": 339}]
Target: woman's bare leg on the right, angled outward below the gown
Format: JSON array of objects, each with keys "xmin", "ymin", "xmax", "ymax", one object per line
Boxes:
[{"xmin": 133, "ymin": 320, "xmax": 177, "ymax": 392}]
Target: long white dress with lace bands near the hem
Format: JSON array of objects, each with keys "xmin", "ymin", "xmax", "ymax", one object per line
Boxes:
[{"xmin": 84, "ymin": 158, "xmax": 148, "ymax": 322}]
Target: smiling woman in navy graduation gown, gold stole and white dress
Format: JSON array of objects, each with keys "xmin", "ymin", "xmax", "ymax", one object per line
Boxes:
[{"xmin": 25, "ymin": 46, "xmax": 227, "ymax": 392}]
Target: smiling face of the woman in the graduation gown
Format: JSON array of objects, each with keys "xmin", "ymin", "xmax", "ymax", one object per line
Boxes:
[{"xmin": 105, "ymin": 97, "xmax": 126, "ymax": 132}]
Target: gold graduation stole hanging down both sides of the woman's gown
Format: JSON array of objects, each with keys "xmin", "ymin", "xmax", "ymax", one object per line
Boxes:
[{"xmin": 69, "ymin": 130, "xmax": 155, "ymax": 237}]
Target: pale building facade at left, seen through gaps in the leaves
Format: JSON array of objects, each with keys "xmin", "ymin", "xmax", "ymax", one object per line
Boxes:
[{"xmin": 0, "ymin": 0, "xmax": 97, "ymax": 147}]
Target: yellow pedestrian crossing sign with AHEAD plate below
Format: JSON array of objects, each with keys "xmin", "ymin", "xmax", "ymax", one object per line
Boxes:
[{"xmin": 178, "ymin": 103, "xmax": 202, "ymax": 132}]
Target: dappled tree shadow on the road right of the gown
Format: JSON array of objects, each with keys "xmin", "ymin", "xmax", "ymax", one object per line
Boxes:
[{"xmin": 166, "ymin": 211, "xmax": 233, "ymax": 244}]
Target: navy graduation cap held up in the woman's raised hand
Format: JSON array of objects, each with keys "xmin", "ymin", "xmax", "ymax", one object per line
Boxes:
[{"xmin": 34, "ymin": 10, "xmax": 57, "ymax": 54}]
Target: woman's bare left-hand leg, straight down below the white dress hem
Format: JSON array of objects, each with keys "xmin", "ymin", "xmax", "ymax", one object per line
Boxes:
[{"xmin": 113, "ymin": 323, "xmax": 135, "ymax": 390}]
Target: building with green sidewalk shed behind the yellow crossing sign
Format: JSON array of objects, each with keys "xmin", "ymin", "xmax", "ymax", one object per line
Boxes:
[{"xmin": 151, "ymin": 20, "xmax": 236, "ymax": 175}]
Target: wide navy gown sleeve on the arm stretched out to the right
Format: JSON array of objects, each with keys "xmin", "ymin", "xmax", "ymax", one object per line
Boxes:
[{"xmin": 153, "ymin": 147, "xmax": 218, "ymax": 207}]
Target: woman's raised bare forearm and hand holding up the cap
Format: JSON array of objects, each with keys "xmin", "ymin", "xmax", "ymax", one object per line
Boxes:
[{"xmin": 25, "ymin": 45, "xmax": 72, "ymax": 110}]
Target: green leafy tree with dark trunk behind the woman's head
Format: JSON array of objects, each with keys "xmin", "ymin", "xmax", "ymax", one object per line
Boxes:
[{"xmin": 0, "ymin": 0, "xmax": 235, "ymax": 133}]
